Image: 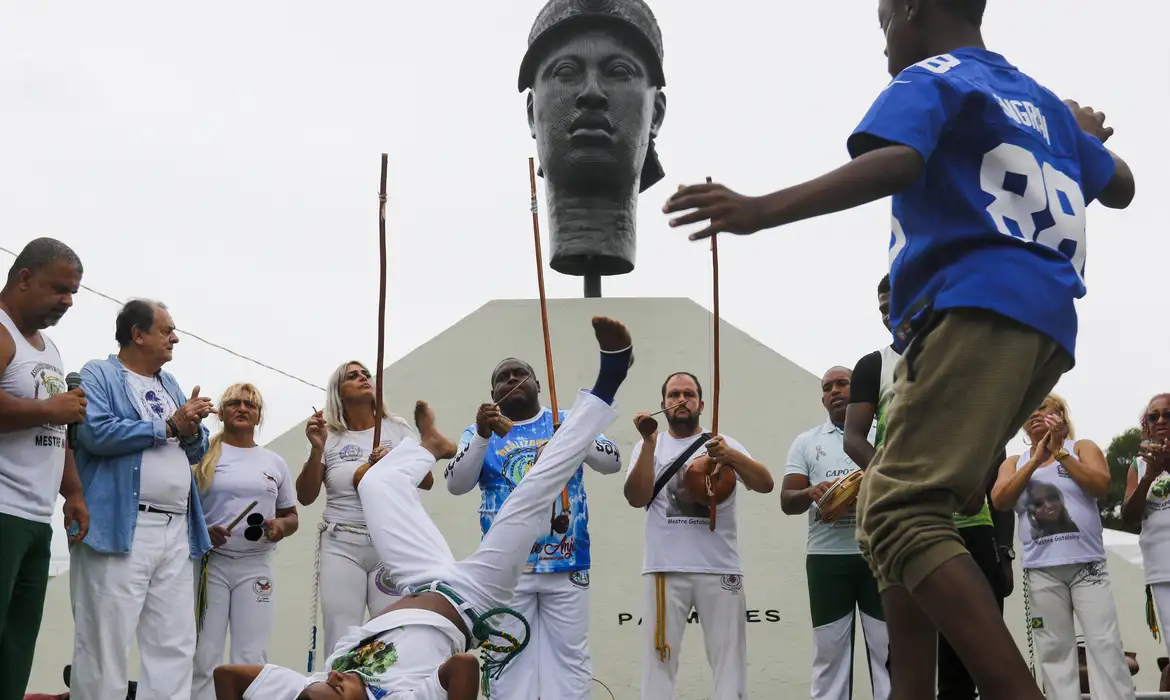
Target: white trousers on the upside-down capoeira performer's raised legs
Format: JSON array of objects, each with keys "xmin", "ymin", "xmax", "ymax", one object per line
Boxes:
[{"xmin": 358, "ymin": 391, "xmax": 618, "ymax": 636}]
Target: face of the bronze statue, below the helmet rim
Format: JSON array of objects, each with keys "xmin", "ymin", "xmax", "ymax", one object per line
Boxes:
[{"xmin": 528, "ymin": 28, "xmax": 666, "ymax": 192}]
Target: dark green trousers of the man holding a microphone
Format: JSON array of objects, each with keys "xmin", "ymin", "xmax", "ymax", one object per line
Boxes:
[{"xmin": 0, "ymin": 513, "xmax": 53, "ymax": 700}]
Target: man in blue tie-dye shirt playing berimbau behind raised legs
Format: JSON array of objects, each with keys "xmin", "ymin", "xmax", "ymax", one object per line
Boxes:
[{"xmin": 445, "ymin": 357, "xmax": 621, "ymax": 700}]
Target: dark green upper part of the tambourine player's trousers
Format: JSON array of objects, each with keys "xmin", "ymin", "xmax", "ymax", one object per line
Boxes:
[{"xmin": 805, "ymin": 554, "xmax": 886, "ymax": 627}]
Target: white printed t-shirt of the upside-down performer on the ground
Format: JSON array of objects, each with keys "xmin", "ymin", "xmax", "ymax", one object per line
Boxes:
[{"xmin": 243, "ymin": 609, "xmax": 466, "ymax": 700}]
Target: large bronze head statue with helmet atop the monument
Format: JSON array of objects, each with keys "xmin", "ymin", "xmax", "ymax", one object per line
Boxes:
[{"xmin": 519, "ymin": 0, "xmax": 666, "ymax": 296}]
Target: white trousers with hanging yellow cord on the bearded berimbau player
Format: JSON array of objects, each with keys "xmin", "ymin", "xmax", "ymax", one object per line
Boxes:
[{"xmin": 642, "ymin": 574, "xmax": 748, "ymax": 700}]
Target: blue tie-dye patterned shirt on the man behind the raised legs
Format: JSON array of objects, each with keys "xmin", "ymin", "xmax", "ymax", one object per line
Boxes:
[{"xmin": 459, "ymin": 407, "xmax": 617, "ymax": 574}]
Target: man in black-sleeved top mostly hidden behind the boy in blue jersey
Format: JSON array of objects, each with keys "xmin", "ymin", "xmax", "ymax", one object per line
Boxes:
[{"xmin": 845, "ymin": 275, "xmax": 1016, "ymax": 700}]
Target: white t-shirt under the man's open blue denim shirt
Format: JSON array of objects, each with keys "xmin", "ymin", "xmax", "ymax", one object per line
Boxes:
[{"xmin": 126, "ymin": 370, "xmax": 191, "ymax": 513}]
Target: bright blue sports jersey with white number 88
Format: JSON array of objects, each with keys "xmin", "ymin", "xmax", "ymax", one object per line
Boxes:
[{"xmin": 848, "ymin": 48, "xmax": 1115, "ymax": 362}]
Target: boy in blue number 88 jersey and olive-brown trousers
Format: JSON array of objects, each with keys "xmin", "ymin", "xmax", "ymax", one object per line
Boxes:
[{"xmin": 663, "ymin": 0, "xmax": 1134, "ymax": 699}]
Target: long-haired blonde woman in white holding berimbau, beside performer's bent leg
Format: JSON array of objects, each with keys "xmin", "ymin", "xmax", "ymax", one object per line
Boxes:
[{"xmin": 296, "ymin": 361, "xmax": 434, "ymax": 673}]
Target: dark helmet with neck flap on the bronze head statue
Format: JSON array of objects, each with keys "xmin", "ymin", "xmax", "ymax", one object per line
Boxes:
[{"xmin": 518, "ymin": 0, "xmax": 666, "ymax": 192}]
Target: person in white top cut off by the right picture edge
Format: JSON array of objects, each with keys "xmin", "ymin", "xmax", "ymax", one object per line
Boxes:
[{"xmin": 1121, "ymin": 393, "xmax": 1170, "ymax": 674}]
